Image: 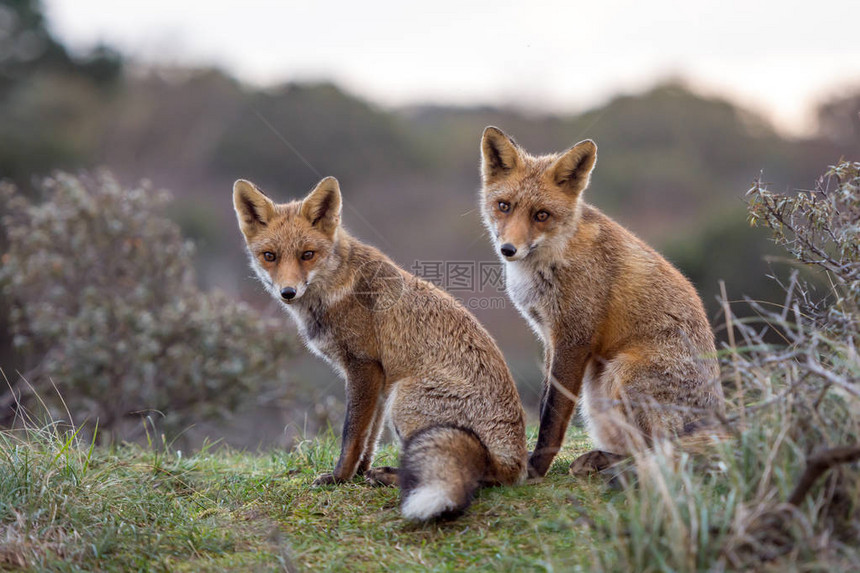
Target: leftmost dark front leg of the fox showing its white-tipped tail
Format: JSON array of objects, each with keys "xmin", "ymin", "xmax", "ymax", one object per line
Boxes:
[{"xmin": 313, "ymin": 362, "xmax": 384, "ymax": 485}]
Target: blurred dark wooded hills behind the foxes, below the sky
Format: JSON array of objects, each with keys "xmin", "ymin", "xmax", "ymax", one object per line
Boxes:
[{"xmin": 0, "ymin": 0, "xmax": 860, "ymax": 438}]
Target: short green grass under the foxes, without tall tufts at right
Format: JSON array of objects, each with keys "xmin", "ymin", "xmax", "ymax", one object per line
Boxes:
[{"xmin": 0, "ymin": 426, "xmax": 618, "ymax": 571}]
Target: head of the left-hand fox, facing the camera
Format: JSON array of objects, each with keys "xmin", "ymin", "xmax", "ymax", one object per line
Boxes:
[{"xmin": 233, "ymin": 177, "xmax": 341, "ymax": 304}]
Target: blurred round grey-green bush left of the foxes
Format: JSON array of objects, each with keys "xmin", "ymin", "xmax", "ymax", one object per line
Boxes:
[{"xmin": 0, "ymin": 173, "xmax": 292, "ymax": 438}]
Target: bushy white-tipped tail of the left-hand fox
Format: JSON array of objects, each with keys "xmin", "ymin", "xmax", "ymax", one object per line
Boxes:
[{"xmin": 400, "ymin": 426, "xmax": 490, "ymax": 521}]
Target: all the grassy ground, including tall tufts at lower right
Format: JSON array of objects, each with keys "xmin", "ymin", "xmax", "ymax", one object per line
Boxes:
[{"xmin": 0, "ymin": 406, "xmax": 860, "ymax": 571}]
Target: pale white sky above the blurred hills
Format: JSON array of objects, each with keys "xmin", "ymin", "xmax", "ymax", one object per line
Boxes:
[{"xmin": 44, "ymin": 0, "xmax": 860, "ymax": 134}]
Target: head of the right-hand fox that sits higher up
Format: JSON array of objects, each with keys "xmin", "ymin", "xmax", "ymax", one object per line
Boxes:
[{"xmin": 481, "ymin": 127, "xmax": 597, "ymax": 261}]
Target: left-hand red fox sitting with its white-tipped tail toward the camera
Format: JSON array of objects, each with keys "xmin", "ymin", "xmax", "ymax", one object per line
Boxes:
[{"xmin": 233, "ymin": 177, "xmax": 527, "ymax": 520}]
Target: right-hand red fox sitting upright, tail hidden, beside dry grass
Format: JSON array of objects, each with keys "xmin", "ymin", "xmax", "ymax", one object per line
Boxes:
[{"xmin": 481, "ymin": 127, "xmax": 725, "ymax": 476}]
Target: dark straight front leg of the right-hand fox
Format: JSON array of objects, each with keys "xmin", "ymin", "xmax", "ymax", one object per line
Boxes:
[{"xmin": 529, "ymin": 346, "xmax": 588, "ymax": 477}]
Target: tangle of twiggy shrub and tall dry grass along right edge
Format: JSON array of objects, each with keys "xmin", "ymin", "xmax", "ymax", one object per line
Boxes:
[{"xmin": 594, "ymin": 162, "xmax": 860, "ymax": 571}]
